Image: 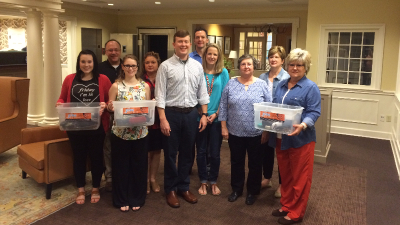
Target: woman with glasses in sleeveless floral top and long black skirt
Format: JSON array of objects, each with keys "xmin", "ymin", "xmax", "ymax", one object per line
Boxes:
[{"xmin": 107, "ymin": 55, "xmax": 151, "ymax": 212}]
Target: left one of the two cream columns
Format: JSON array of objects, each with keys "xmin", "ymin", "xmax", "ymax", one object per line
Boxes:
[{"xmin": 26, "ymin": 9, "xmax": 44, "ymax": 125}]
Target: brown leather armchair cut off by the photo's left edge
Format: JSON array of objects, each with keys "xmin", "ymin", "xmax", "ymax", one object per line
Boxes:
[{"xmin": 0, "ymin": 77, "xmax": 29, "ymax": 153}]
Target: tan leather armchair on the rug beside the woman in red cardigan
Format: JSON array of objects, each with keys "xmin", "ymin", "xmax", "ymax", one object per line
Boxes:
[{"xmin": 17, "ymin": 125, "xmax": 74, "ymax": 199}]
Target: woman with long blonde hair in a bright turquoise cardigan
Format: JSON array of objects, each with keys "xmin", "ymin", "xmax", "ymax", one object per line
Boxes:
[{"xmin": 196, "ymin": 44, "xmax": 229, "ymax": 195}]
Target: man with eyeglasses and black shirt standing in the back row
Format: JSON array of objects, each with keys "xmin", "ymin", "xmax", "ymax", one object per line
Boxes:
[{"xmin": 99, "ymin": 39, "xmax": 122, "ymax": 192}]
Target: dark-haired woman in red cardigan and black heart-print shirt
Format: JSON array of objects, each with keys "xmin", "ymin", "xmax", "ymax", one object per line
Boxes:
[{"xmin": 56, "ymin": 50, "xmax": 111, "ymax": 204}]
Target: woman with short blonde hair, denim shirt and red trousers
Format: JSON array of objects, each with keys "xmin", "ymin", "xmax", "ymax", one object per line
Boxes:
[{"xmin": 269, "ymin": 48, "xmax": 321, "ymax": 224}]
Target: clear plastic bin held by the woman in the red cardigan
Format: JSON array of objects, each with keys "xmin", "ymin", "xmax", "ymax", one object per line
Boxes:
[{"xmin": 57, "ymin": 102, "xmax": 100, "ymax": 131}]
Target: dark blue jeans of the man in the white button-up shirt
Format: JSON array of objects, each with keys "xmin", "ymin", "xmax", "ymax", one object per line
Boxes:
[{"xmin": 163, "ymin": 108, "xmax": 199, "ymax": 194}]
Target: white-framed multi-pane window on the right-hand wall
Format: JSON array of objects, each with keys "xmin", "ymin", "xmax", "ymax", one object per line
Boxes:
[{"xmin": 318, "ymin": 25, "xmax": 384, "ymax": 89}]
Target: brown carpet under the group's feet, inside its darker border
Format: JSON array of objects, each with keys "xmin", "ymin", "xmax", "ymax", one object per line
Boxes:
[{"xmin": 35, "ymin": 135, "xmax": 374, "ymax": 225}]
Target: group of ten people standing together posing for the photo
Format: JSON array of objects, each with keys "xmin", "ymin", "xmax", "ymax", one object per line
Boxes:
[{"xmin": 57, "ymin": 28, "xmax": 321, "ymax": 224}]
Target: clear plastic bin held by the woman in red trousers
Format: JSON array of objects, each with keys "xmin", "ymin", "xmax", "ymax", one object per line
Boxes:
[{"xmin": 254, "ymin": 102, "xmax": 303, "ymax": 134}]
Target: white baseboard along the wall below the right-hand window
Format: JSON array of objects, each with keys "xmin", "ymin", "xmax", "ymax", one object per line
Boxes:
[{"xmin": 331, "ymin": 126, "xmax": 392, "ymax": 140}]
